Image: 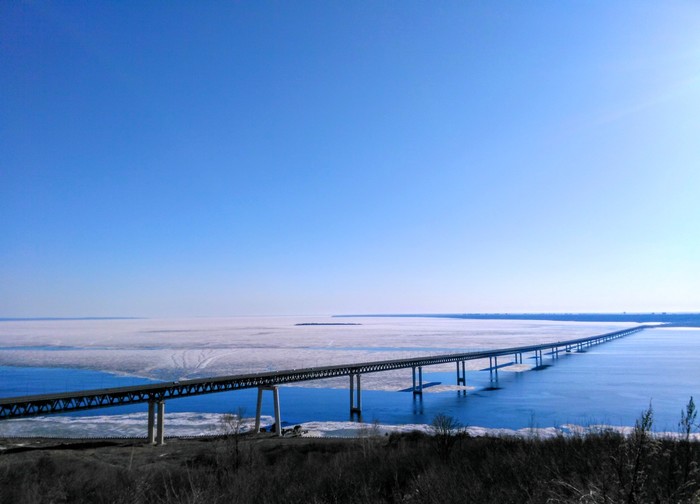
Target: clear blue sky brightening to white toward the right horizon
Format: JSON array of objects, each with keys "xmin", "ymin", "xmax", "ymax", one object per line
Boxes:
[{"xmin": 0, "ymin": 0, "xmax": 700, "ymax": 317}]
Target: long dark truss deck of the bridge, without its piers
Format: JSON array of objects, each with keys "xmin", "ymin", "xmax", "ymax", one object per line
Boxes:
[{"xmin": 0, "ymin": 325, "xmax": 649, "ymax": 420}]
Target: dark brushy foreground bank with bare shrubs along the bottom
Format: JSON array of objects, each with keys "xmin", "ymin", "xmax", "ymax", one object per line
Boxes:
[{"xmin": 0, "ymin": 415, "xmax": 700, "ymax": 504}]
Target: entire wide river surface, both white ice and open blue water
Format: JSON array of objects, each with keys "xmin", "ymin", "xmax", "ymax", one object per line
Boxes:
[{"xmin": 0, "ymin": 317, "xmax": 700, "ymax": 436}]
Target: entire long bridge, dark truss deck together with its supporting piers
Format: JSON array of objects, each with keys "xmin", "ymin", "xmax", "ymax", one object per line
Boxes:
[{"xmin": 0, "ymin": 325, "xmax": 652, "ymax": 444}]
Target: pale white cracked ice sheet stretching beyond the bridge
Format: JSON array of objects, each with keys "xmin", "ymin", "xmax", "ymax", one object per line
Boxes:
[{"xmin": 0, "ymin": 316, "xmax": 634, "ymax": 390}]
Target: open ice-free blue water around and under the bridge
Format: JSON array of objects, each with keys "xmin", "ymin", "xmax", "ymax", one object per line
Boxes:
[{"xmin": 0, "ymin": 329, "xmax": 700, "ymax": 431}]
